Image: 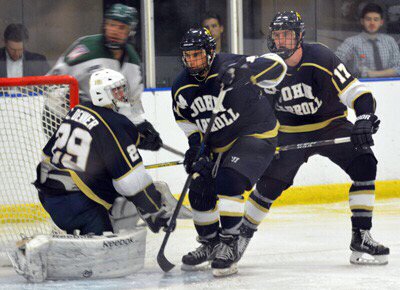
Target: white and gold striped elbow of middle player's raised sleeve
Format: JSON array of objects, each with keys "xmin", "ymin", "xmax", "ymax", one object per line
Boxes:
[{"xmin": 252, "ymin": 53, "xmax": 287, "ymax": 89}]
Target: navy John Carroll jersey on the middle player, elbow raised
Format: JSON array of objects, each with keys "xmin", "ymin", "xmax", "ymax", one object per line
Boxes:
[{"xmin": 172, "ymin": 53, "xmax": 286, "ymax": 152}]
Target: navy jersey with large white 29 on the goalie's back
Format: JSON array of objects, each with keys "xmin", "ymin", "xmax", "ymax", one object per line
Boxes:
[{"xmin": 41, "ymin": 103, "xmax": 142, "ymax": 208}]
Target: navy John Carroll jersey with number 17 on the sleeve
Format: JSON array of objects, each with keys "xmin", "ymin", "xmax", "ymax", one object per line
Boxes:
[{"xmin": 265, "ymin": 43, "xmax": 370, "ymax": 133}]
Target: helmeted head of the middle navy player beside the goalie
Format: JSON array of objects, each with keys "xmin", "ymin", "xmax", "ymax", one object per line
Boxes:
[{"xmin": 180, "ymin": 28, "xmax": 216, "ymax": 77}]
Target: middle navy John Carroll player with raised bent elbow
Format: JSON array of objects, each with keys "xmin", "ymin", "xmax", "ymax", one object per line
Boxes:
[{"xmin": 172, "ymin": 28, "xmax": 286, "ymax": 276}]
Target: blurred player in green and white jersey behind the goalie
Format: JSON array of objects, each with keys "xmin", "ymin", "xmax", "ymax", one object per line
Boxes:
[{"xmin": 48, "ymin": 4, "xmax": 162, "ymax": 150}]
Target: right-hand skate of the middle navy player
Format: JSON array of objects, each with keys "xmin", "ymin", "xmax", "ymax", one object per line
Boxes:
[{"xmin": 211, "ymin": 234, "xmax": 239, "ymax": 277}]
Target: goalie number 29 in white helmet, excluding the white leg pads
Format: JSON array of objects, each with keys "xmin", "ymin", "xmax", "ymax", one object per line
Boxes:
[{"xmin": 35, "ymin": 69, "xmax": 167, "ymax": 235}]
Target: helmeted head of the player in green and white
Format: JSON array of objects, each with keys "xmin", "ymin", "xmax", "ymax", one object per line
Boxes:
[{"xmin": 104, "ymin": 4, "xmax": 138, "ymax": 49}]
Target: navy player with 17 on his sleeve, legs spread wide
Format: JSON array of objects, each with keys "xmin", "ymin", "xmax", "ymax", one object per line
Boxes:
[{"xmin": 240, "ymin": 11, "xmax": 389, "ymax": 264}]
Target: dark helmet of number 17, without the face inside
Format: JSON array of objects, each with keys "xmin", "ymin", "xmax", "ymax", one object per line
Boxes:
[{"xmin": 267, "ymin": 11, "xmax": 305, "ymax": 59}]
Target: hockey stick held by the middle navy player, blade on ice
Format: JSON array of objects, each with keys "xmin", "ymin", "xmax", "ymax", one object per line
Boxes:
[{"xmin": 157, "ymin": 86, "xmax": 231, "ymax": 272}]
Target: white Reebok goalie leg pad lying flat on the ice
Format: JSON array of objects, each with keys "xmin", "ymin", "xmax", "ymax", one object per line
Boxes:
[{"xmin": 9, "ymin": 228, "xmax": 146, "ymax": 282}]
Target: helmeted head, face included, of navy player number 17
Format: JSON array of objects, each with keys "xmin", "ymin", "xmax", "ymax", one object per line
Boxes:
[{"xmin": 267, "ymin": 11, "xmax": 305, "ymax": 59}]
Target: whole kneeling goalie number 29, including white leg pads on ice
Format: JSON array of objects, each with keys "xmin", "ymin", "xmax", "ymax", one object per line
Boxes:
[{"xmin": 9, "ymin": 69, "xmax": 190, "ymax": 282}]
